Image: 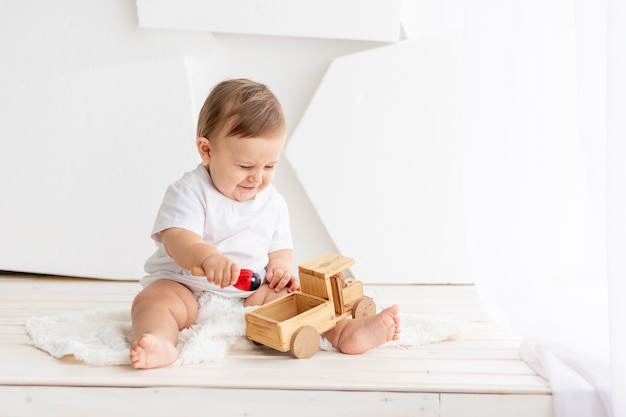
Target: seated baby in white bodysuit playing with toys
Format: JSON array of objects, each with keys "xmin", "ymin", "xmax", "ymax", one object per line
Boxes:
[{"xmin": 130, "ymin": 79, "xmax": 400, "ymax": 369}]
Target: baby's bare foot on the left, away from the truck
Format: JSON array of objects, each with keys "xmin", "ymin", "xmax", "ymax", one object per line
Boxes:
[{"xmin": 130, "ymin": 334, "xmax": 178, "ymax": 369}]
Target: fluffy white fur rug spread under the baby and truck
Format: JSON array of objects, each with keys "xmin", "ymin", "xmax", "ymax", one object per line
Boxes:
[{"xmin": 26, "ymin": 293, "xmax": 469, "ymax": 365}]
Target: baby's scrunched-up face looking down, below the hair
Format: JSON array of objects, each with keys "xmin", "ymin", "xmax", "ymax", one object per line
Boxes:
[{"xmin": 208, "ymin": 132, "xmax": 286, "ymax": 201}]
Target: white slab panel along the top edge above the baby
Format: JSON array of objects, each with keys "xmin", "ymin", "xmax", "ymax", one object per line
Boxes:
[{"xmin": 137, "ymin": 0, "xmax": 401, "ymax": 41}]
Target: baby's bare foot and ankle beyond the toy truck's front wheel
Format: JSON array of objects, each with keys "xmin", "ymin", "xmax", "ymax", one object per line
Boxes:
[{"xmin": 324, "ymin": 305, "xmax": 400, "ymax": 354}]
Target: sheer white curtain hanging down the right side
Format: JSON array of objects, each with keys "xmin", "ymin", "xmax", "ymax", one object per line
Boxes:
[{"xmin": 463, "ymin": 0, "xmax": 626, "ymax": 417}]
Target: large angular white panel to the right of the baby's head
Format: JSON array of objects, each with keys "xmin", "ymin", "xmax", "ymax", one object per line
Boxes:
[{"xmin": 286, "ymin": 32, "xmax": 470, "ymax": 283}]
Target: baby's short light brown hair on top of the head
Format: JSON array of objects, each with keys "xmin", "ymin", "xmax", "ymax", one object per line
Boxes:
[{"xmin": 198, "ymin": 78, "xmax": 286, "ymax": 138}]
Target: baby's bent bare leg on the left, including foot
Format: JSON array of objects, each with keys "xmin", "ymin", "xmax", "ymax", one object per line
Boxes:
[{"xmin": 130, "ymin": 280, "xmax": 198, "ymax": 369}]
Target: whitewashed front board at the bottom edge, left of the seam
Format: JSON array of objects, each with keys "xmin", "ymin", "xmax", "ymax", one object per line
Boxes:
[{"xmin": 0, "ymin": 387, "xmax": 439, "ymax": 417}]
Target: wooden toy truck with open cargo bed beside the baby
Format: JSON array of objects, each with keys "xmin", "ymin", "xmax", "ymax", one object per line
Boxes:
[{"xmin": 246, "ymin": 253, "xmax": 376, "ymax": 359}]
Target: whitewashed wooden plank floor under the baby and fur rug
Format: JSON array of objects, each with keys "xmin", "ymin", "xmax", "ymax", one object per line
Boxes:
[{"xmin": 0, "ymin": 274, "xmax": 553, "ymax": 417}]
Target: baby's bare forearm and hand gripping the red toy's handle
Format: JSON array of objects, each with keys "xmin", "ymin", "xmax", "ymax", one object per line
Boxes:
[{"xmin": 161, "ymin": 227, "xmax": 239, "ymax": 288}]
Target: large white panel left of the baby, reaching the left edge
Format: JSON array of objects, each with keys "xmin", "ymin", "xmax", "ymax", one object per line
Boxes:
[{"xmin": 0, "ymin": 58, "xmax": 198, "ymax": 278}]
